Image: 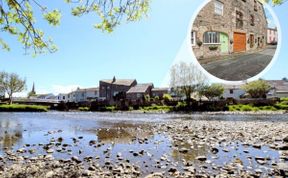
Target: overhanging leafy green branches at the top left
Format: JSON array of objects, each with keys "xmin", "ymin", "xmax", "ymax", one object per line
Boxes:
[{"xmin": 0, "ymin": 0, "xmax": 149, "ymax": 54}]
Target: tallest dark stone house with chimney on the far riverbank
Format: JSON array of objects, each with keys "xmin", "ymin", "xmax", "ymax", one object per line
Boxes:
[{"xmin": 99, "ymin": 77, "xmax": 137, "ymax": 104}]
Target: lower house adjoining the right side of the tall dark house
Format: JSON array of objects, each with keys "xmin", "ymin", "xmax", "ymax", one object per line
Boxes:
[{"xmin": 126, "ymin": 83, "xmax": 154, "ymax": 102}]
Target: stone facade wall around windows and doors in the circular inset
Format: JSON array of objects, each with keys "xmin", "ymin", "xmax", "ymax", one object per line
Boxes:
[{"xmin": 192, "ymin": 0, "xmax": 267, "ymax": 59}]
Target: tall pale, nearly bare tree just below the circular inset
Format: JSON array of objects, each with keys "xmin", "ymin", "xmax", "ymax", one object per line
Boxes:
[{"xmin": 170, "ymin": 62, "xmax": 206, "ymax": 104}]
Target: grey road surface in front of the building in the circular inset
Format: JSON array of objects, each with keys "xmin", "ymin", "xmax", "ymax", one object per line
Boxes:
[{"xmin": 201, "ymin": 46, "xmax": 277, "ymax": 81}]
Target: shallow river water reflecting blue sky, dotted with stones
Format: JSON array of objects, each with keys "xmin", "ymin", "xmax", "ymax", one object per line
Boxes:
[{"xmin": 0, "ymin": 112, "xmax": 287, "ymax": 176}]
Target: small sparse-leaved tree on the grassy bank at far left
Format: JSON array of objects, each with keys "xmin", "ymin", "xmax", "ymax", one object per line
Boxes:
[{"xmin": 0, "ymin": 72, "xmax": 26, "ymax": 104}]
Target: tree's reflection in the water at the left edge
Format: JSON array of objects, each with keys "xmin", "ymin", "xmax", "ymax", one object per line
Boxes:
[{"xmin": 0, "ymin": 119, "xmax": 22, "ymax": 150}]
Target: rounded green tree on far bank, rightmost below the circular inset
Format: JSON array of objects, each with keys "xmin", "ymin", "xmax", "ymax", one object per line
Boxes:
[{"xmin": 242, "ymin": 80, "xmax": 271, "ymax": 98}]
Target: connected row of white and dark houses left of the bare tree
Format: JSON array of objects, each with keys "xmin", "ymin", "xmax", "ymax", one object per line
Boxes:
[{"xmin": 52, "ymin": 77, "xmax": 169, "ymax": 104}]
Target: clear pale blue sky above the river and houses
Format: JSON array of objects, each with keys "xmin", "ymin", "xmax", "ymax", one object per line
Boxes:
[{"xmin": 0, "ymin": 0, "xmax": 288, "ymax": 95}]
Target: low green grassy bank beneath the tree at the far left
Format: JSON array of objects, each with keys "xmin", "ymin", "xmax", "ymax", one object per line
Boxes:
[{"xmin": 0, "ymin": 104, "xmax": 48, "ymax": 112}]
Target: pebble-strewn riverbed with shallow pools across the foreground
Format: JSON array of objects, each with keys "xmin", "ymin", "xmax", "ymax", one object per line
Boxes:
[{"xmin": 0, "ymin": 115, "xmax": 288, "ymax": 178}]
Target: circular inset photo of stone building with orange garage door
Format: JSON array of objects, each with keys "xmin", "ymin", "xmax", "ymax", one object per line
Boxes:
[{"xmin": 191, "ymin": 0, "xmax": 278, "ymax": 81}]
